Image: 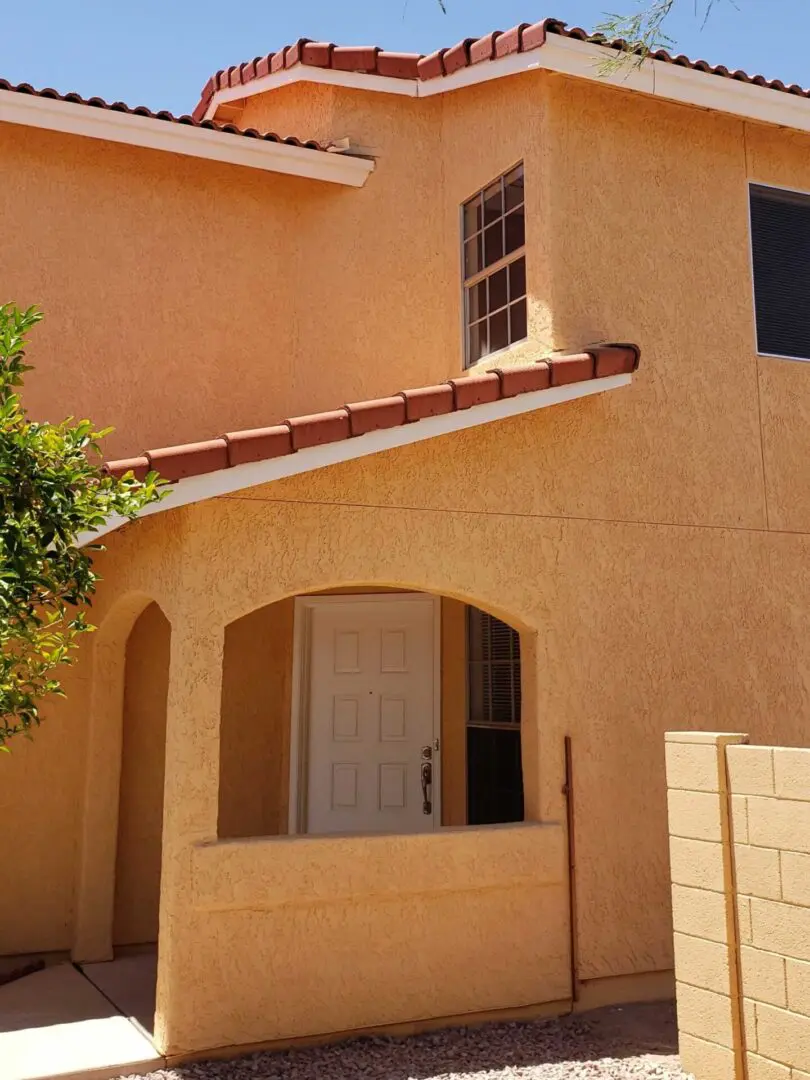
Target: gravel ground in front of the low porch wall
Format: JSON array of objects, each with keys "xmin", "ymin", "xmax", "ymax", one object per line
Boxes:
[{"xmin": 120, "ymin": 1003, "xmax": 686, "ymax": 1080}]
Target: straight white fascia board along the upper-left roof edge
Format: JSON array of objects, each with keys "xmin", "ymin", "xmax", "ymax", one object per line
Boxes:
[{"xmin": 0, "ymin": 90, "xmax": 374, "ymax": 188}]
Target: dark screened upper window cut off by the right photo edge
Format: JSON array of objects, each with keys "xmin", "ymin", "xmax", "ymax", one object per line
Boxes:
[{"xmin": 751, "ymin": 185, "xmax": 810, "ymax": 360}]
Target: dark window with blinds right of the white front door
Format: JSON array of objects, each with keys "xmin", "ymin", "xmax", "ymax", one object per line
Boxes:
[{"xmin": 467, "ymin": 607, "xmax": 523, "ymax": 825}]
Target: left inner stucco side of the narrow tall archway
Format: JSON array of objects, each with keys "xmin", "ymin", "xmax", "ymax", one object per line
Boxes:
[{"xmin": 71, "ymin": 590, "xmax": 171, "ymax": 961}]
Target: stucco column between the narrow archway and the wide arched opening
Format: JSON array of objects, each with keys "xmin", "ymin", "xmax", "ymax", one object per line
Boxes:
[{"xmin": 154, "ymin": 612, "xmax": 225, "ymax": 1052}]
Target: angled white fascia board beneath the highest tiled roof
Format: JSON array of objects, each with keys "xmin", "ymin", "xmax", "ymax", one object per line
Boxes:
[{"xmin": 206, "ymin": 33, "xmax": 810, "ymax": 131}]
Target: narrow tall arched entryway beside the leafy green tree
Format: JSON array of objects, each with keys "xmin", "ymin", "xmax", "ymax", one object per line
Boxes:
[{"xmin": 73, "ymin": 596, "xmax": 171, "ymax": 1032}]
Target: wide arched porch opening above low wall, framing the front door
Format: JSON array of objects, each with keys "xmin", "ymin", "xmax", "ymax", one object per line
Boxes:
[{"xmin": 218, "ymin": 585, "xmax": 524, "ymax": 838}]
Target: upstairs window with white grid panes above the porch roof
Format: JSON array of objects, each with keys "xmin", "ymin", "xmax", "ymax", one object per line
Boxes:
[{"xmin": 462, "ymin": 164, "xmax": 526, "ymax": 367}]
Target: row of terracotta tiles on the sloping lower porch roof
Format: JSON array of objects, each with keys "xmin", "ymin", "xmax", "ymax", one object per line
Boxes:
[{"xmin": 105, "ymin": 341, "xmax": 640, "ymax": 483}]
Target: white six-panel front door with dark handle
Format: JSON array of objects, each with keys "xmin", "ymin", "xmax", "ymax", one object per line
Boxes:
[{"xmin": 291, "ymin": 593, "xmax": 440, "ymax": 834}]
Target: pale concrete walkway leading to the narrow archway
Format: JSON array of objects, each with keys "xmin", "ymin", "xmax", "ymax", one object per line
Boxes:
[{"xmin": 0, "ymin": 963, "xmax": 163, "ymax": 1080}]
